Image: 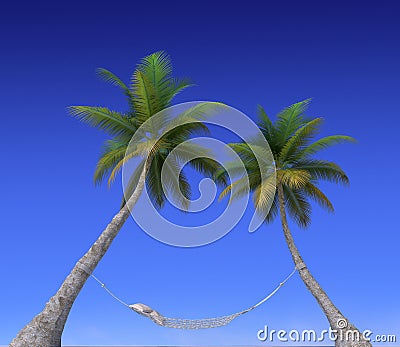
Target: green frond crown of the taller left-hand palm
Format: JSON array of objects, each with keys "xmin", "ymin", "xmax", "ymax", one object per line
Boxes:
[{"xmin": 69, "ymin": 51, "xmax": 225, "ymax": 207}]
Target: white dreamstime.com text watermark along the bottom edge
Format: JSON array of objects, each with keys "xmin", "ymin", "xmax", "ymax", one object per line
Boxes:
[{"xmin": 257, "ymin": 318, "xmax": 397, "ymax": 343}]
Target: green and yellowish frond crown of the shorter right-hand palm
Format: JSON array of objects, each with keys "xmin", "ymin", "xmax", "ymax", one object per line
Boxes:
[{"xmin": 221, "ymin": 99, "xmax": 354, "ymax": 227}]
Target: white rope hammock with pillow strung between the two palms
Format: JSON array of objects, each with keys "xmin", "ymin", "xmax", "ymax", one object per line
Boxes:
[{"xmin": 77, "ymin": 262, "xmax": 305, "ymax": 329}]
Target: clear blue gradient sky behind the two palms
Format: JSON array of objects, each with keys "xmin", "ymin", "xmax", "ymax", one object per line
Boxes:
[{"xmin": 0, "ymin": 1, "xmax": 400, "ymax": 345}]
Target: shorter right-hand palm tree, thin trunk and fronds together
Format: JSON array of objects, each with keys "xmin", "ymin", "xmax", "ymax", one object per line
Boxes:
[{"xmin": 220, "ymin": 99, "xmax": 371, "ymax": 346}]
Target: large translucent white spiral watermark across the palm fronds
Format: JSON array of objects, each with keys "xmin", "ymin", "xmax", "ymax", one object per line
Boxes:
[{"xmin": 122, "ymin": 102, "xmax": 275, "ymax": 247}]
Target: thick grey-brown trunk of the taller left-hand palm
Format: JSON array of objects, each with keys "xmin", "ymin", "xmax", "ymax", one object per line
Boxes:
[{"xmin": 9, "ymin": 165, "xmax": 147, "ymax": 347}]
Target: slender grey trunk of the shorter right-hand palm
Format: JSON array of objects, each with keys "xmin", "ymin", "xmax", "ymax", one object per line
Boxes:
[{"xmin": 277, "ymin": 185, "xmax": 372, "ymax": 347}]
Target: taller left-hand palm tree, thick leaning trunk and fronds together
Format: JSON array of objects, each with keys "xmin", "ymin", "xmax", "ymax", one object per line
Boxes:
[{"xmin": 10, "ymin": 52, "xmax": 227, "ymax": 347}]
